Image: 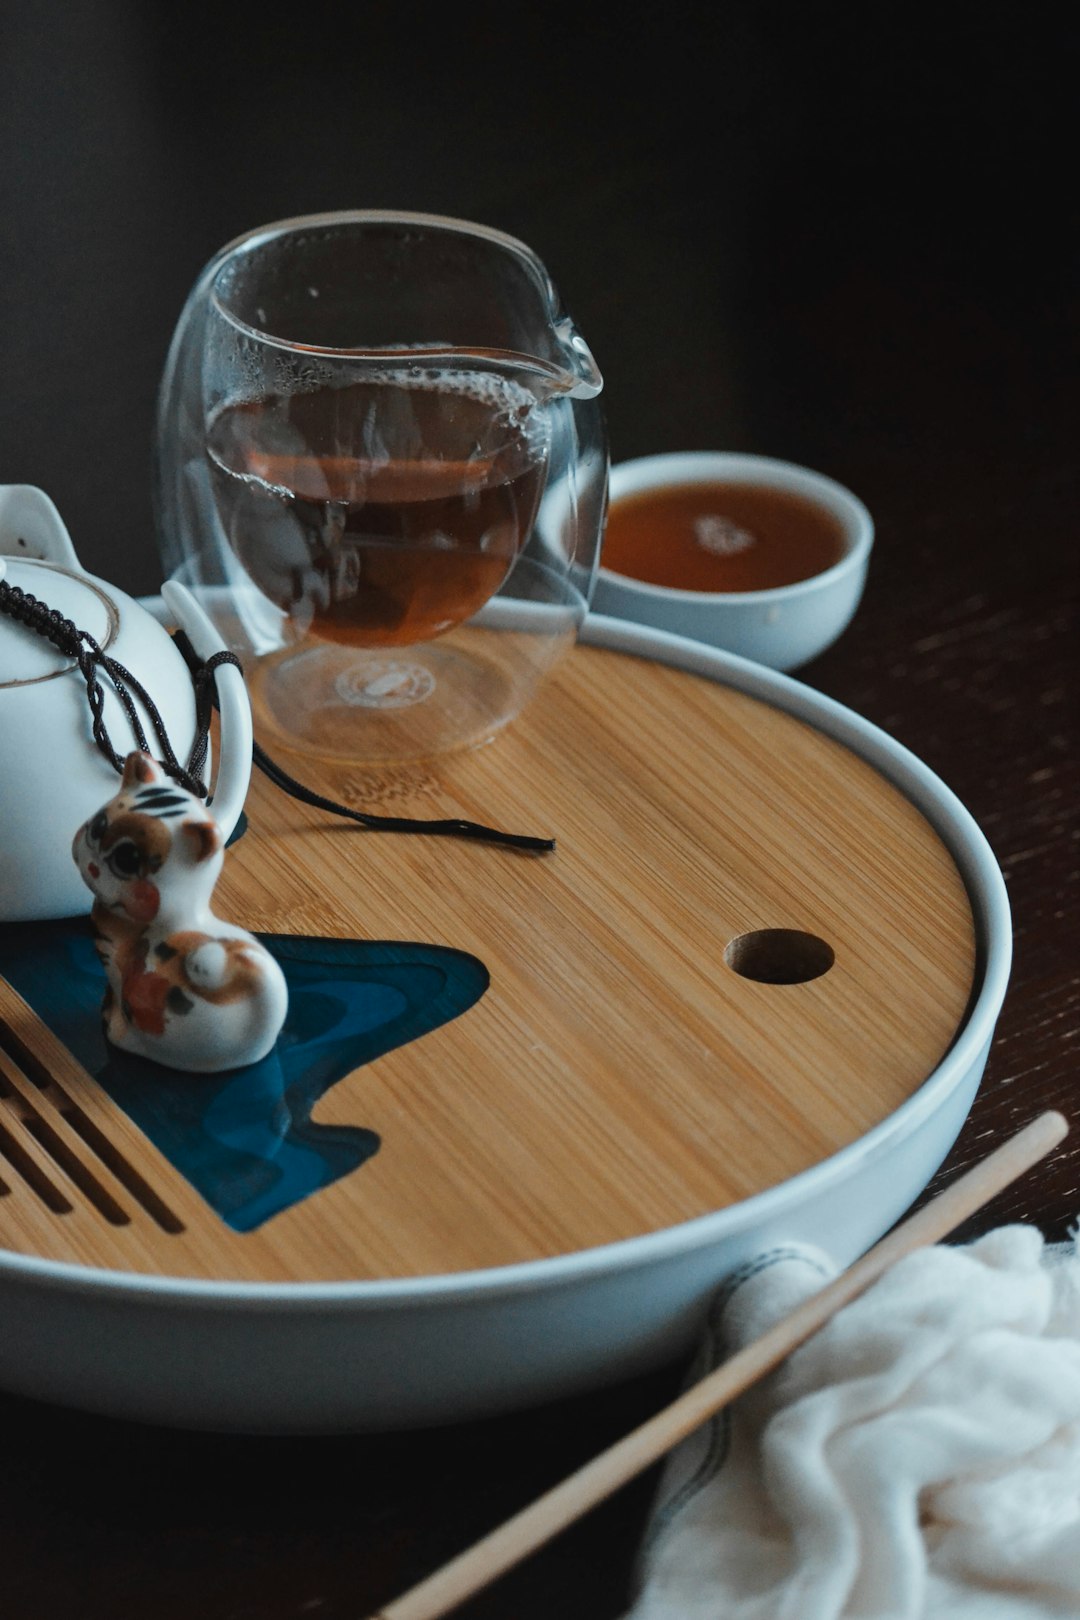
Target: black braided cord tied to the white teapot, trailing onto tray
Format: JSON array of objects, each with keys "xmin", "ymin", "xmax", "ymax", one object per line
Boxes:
[{"xmin": 0, "ymin": 578, "xmax": 555, "ymax": 852}]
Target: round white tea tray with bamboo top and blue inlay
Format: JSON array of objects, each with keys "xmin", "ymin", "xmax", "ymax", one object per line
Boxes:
[{"xmin": 0, "ymin": 617, "xmax": 1010, "ymax": 1432}]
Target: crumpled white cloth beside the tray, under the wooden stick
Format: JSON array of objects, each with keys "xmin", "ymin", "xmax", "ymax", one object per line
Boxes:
[{"xmin": 625, "ymin": 1226, "xmax": 1080, "ymax": 1620}]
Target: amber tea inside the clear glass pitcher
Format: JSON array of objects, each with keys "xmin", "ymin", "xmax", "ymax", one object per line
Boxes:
[{"xmin": 207, "ymin": 373, "xmax": 547, "ymax": 646}]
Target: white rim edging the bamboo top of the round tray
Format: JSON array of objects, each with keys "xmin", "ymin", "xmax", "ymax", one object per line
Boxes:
[{"xmin": 0, "ymin": 612, "xmax": 1012, "ymax": 1315}]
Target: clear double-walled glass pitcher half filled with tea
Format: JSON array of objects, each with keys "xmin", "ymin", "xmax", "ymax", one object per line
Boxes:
[{"xmin": 155, "ymin": 211, "xmax": 609, "ymax": 763}]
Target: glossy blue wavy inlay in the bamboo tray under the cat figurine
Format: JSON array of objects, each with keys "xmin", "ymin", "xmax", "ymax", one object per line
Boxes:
[{"xmin": 0, "ymin": 919, "xmax": 487, "ymax": 1231}]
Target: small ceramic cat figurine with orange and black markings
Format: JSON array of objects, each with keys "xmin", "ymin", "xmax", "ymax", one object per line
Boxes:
[{"xmin": 71, "ymin": 752, "xmax": 288, "ymax": 1074}]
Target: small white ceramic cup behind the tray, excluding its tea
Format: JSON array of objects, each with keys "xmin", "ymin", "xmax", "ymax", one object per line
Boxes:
[{"xmin": 593, "ymin": 450, "xmax": 874, "ymax": 669}]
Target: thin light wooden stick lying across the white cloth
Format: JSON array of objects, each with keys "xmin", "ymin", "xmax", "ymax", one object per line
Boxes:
[{"xmin": 369, "ymin": 1110, "xmax": 1069, "ymax": 1620}]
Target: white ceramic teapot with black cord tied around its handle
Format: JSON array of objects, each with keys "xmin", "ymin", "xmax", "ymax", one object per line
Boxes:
[{"xmin": 0, "ymin": 484, "xmax": 253, "ymax": 923}]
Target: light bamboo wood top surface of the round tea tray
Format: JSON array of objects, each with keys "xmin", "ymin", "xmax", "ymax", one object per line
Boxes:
[{"xmin": 0, "ymin": 646, "xmax": 975, "ymax": 1281}]
